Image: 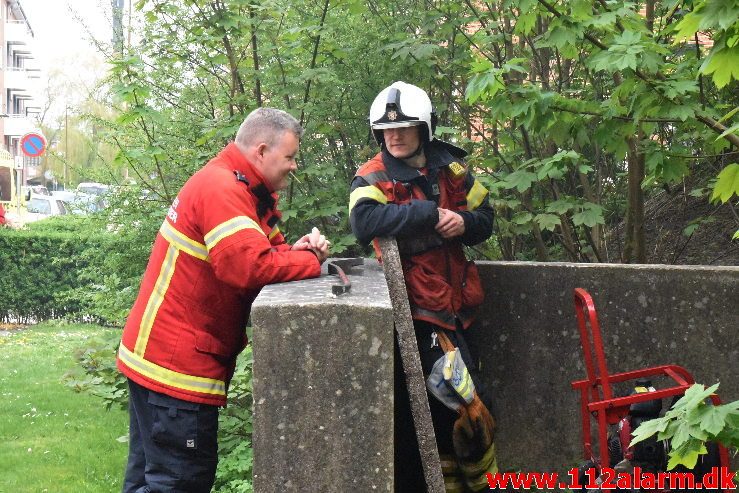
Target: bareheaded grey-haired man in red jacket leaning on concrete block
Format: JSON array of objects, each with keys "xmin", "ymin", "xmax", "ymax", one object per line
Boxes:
[{"xmin": 117, "ymin": 108, "xmax": 329, "ymax": 493}]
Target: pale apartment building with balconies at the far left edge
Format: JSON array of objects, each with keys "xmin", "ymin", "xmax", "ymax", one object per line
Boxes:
[{"xmin": 0, "ymin": 0, "xmax": 40, "ymax": 202}]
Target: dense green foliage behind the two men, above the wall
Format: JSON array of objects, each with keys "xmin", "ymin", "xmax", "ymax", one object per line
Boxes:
[{"xmin": 82, "ymin": 0, "xmax": 739, "ymax": 264}]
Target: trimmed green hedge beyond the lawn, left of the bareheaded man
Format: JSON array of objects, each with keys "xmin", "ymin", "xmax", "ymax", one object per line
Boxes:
[{"xmin": 0, "ymin": 216, "xmax": 153, "ymax": 325}]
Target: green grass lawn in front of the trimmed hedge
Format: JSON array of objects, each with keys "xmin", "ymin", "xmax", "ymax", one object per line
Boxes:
[{"xmin": 0, "ymin": 323, "xmax": 128, "ymax": 493}]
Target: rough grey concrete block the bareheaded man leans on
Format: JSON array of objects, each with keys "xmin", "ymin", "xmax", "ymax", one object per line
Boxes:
[{"xmin": 252, "ymin": 264, "xmax": 394, "ymax": 493}]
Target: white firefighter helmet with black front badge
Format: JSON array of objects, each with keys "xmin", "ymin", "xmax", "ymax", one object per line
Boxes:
[{"xmin": 369, "ymin": 81, "xmax": 436, "ymax": 145}]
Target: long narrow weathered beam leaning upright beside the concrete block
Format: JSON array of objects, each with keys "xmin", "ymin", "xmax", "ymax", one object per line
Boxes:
[{"xmin": 379, "ymin": 238, "xmax": 444, "ymax": 493}]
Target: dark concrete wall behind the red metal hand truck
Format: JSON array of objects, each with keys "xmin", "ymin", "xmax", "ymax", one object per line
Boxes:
[{"xmin": 468, "ymin": 262, "xmax": 739, "ymax": 471}]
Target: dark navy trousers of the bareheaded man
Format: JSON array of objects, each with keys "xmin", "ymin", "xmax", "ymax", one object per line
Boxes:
[{"xmin": 123, "ymin": 379, "xmax": 218, "ymax": 493}]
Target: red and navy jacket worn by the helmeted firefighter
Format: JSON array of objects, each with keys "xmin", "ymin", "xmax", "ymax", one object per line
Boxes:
[{"xmin": 349, "ymin": 140, "xmax": 493, "ymax": 330}]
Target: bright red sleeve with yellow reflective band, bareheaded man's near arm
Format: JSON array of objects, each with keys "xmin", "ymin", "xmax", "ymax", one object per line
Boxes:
[{"xmin": 195, "ymin": 182, "xmax": 321, "ymax": 289}]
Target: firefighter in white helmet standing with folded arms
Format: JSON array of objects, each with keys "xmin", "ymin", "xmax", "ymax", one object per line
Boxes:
[{"xmin": 349, "ymin": 82, "xmax": 497, "ymax": 491}]
